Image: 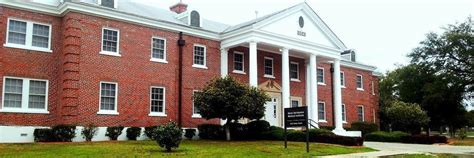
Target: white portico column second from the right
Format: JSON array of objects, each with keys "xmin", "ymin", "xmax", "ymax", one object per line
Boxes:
[{"xmin": 309, "ymin": 54, "xmax": 318, "ymax": 122}]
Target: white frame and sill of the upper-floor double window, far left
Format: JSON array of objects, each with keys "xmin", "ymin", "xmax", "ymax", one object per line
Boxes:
[{"xmin": 3, "ymin": 17, "xmax": 53, "ymax": 53}]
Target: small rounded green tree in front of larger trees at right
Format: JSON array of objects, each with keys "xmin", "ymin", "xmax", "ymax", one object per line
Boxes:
[{"xmin": 385, "ymin": 101, "xmax": 430, "ymax": 134}]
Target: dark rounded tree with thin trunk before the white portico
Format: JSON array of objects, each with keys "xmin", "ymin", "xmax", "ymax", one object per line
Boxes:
[{"xmin": 193, "ymin": 77, "xmax": 270, "ymax": 140}]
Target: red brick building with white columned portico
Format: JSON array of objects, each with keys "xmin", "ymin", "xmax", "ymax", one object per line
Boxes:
[{"xmin": 0, "ymin": 0, "xmax": 378, "ymax": 142}]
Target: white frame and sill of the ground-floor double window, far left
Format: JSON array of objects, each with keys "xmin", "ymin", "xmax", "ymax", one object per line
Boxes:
[{"xmin": 0, "ymin": 76, "xmax": 49, "ymax": 114}]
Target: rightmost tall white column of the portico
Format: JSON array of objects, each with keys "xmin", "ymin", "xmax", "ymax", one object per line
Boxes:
[{"xmin": 332, "ymin": 59, "xmax": 345, "ymax": 133}]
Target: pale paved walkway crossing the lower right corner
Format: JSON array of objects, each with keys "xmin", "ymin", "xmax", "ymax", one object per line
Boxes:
[{"xmin": 326, "ymin": 142, "xmax": 474, "ymax": 157}]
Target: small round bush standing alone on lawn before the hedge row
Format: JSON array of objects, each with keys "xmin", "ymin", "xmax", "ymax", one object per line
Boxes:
[{"xmin": 156, "ymin": 122, "xmax": 183, "ymax": 152}]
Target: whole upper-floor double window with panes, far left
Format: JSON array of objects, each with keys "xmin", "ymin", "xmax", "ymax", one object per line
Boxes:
[{"xmin": 3, "ymin": 18, "xmax": 53, "ymax": 52}]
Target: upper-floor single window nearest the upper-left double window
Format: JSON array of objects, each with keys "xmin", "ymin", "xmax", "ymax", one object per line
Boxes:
[{"xmin": 99, "ymin": 27, "xmax": 121, "ymax": 56}]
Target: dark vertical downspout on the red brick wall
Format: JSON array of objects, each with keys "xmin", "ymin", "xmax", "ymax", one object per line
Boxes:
[{"xmin": 178, "ymin": 32, "xmax": 186, "ymax": 128}]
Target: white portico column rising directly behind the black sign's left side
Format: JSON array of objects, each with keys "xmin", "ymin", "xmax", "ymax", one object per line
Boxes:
[{"xmin": 281, "ymin": 48, "xmax": 291, "ymax": 108}]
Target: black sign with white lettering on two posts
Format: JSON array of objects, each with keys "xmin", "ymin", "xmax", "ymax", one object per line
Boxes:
[{"xmin": 285, "ymin": 106, "xmax": 309, "ymax": 152}]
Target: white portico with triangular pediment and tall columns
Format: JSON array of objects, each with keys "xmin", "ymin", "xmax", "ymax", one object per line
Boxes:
[{"xmin": 217, "ymin": 3, "xmax": 360, "ymax": 136}]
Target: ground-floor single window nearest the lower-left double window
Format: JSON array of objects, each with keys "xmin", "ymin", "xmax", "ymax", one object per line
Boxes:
[{"xmin": 97, "ymin": 81, "xmax": 119, "ymax": 115}]
